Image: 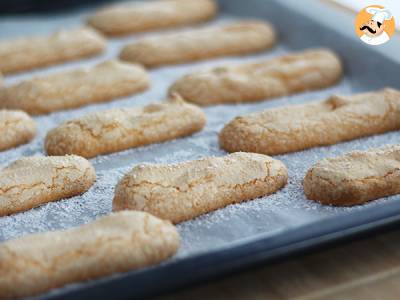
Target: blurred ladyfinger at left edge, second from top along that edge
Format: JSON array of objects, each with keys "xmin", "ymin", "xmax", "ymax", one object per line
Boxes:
[{"xmin": 0, "ymin": 60, "xmax": 150, "ymax": 114}]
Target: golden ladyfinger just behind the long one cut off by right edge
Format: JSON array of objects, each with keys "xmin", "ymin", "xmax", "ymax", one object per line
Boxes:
[{"xmin": 170, "ymin": 49, "xmax": 342, "ymax": 105}]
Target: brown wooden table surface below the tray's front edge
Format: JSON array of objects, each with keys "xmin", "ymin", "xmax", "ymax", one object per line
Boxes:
[{"xmin": 157, "ymin": 229, "xmax": 400, "ymax": 300}]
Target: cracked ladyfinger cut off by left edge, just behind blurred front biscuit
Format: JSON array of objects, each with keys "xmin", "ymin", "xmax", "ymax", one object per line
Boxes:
[{"xmin": 0, "ymin": 155, "xmax": 96, "ymax": 216}]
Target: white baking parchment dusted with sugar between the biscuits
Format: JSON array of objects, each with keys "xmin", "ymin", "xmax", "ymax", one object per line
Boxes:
[{"xmin": 0, "ymin": 7, "xmax": 400, "ymax": 260}]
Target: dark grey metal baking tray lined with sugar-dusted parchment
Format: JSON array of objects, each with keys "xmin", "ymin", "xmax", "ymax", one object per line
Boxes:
[{"xmin": 0, "ymin": 0, "xmax": 400, "ymax": 299}]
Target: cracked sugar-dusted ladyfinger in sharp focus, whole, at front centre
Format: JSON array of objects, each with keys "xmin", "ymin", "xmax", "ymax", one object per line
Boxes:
[{"xmin": 113, "ymin": 152, "xmax": 288, "ymax": 223}]
